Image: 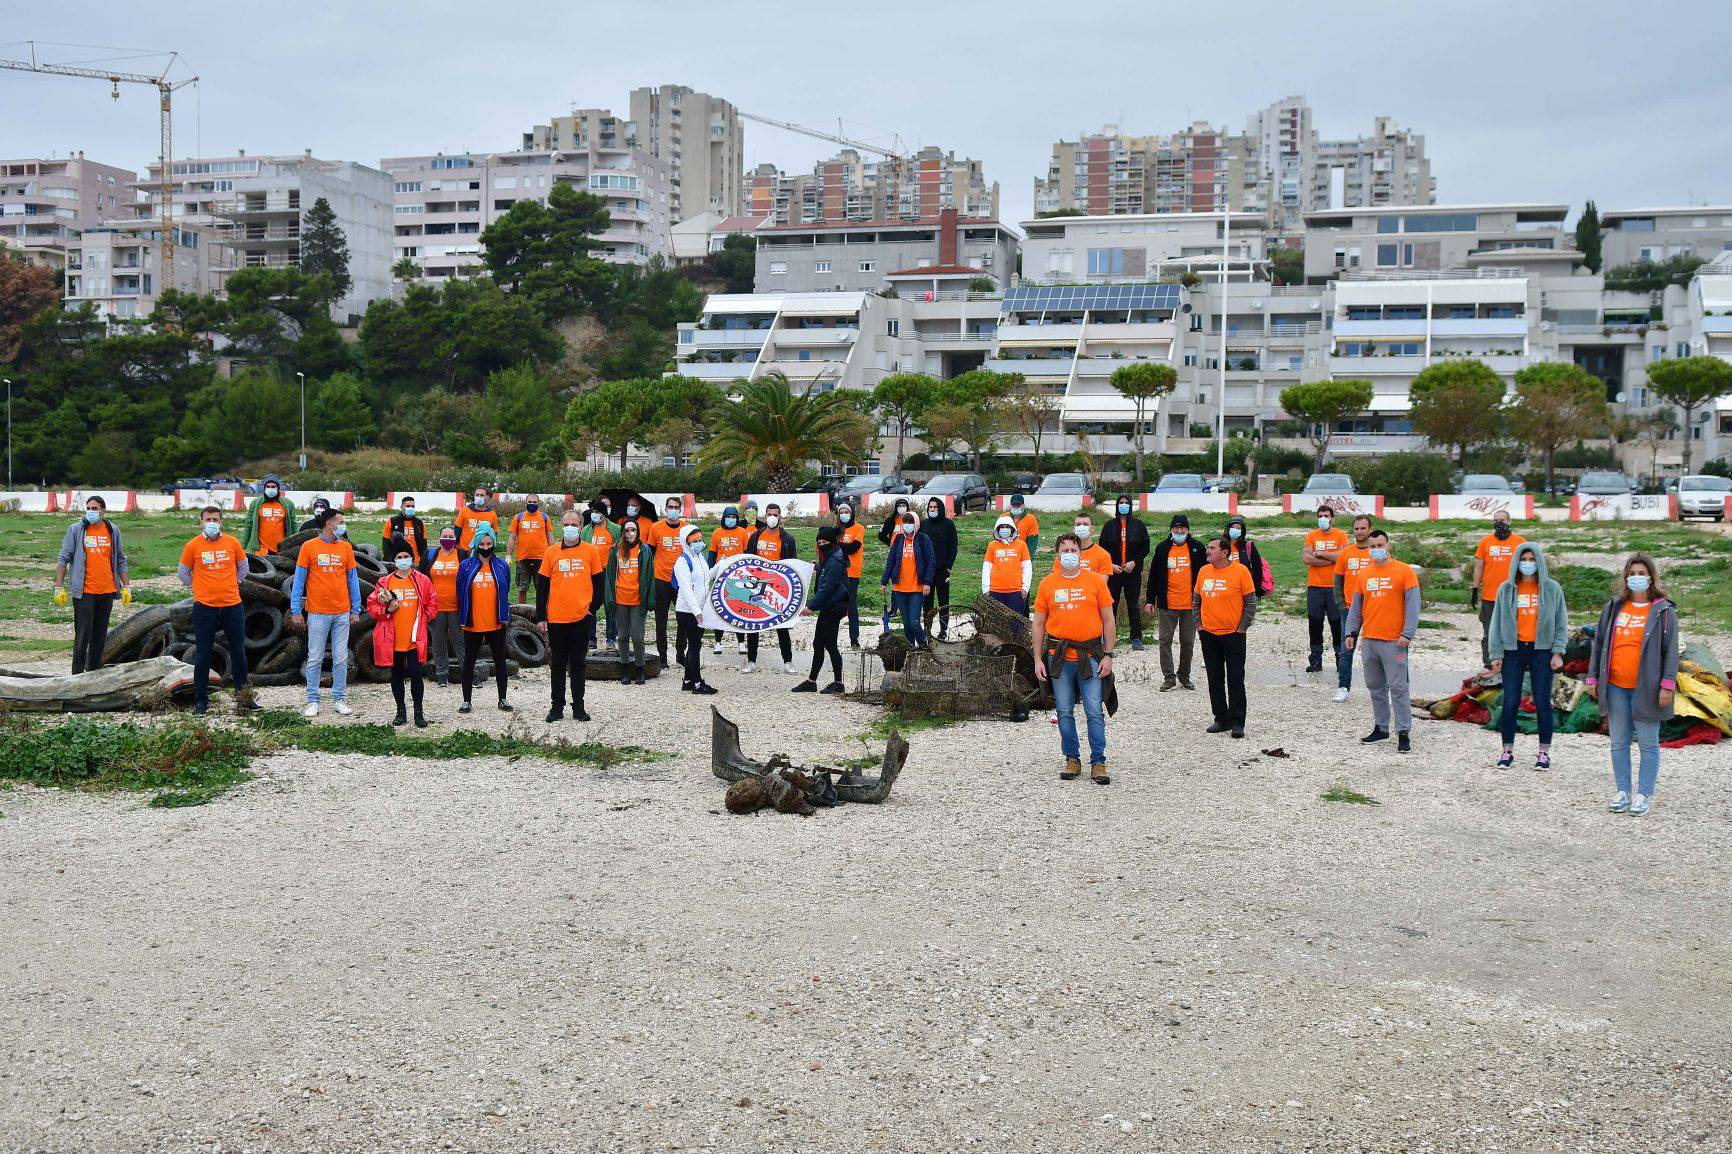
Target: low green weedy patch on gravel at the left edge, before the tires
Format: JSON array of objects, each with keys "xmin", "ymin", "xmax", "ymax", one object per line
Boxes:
[{"xmin": 0, "ymin": 717, "xmax": 258, "ymax": 807}]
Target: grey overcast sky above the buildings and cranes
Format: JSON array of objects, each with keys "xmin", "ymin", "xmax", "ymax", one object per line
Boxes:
[{"xmin": 0, "ymin": 0, "xmax": 1732, "ymax": 222}]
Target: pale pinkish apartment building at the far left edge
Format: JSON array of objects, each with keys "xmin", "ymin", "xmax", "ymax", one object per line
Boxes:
[{"xmin": 0, "ymin": 152, "xmax": 139, "ymax": 269}]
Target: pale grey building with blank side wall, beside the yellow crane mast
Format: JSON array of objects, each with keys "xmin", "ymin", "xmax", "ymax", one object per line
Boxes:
[{"xmin": 135, "ymin": 151, "xmax": 393, "ymax": 319}]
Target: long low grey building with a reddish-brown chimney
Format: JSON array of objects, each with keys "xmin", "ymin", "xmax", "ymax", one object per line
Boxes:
[{"xmin": 753, "ymin": 208, "xmax": 1017, "ymax": 293}]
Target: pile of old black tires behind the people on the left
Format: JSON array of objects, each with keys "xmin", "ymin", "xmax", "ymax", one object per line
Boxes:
[{"xmin": 102, "ymin": 530, "xmax": 547, "ymax": 686}]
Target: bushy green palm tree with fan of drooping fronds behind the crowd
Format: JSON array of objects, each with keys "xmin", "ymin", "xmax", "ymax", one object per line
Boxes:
[{"xmin": 698, "ymin": 373, "xmax": 866, "ymax": 492}]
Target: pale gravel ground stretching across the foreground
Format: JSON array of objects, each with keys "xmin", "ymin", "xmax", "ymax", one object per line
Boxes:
[{"xmin": 0, "ymin": 617, "xmax": 1732, "ymax": 1154}]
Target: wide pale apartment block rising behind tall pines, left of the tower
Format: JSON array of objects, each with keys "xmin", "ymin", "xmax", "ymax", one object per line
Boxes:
[{"xmin": 379, "ymin": 144, "xmax": 672, "ymax": 281}]
